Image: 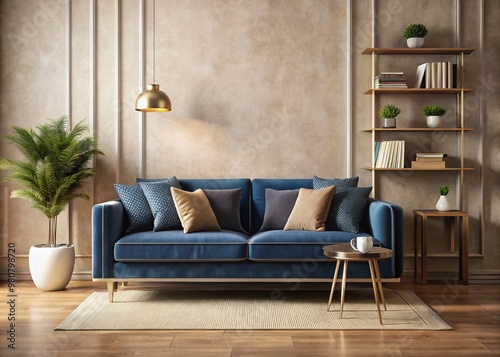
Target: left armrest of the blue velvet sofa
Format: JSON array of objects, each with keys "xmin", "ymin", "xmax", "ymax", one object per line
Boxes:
[{"xmin": 92, "ymin": 200, "xmax": 126, "ymax": 279}]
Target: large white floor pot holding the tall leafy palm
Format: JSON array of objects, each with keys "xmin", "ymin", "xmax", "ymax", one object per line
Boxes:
[{"xmin": 29, "ymin": 244, "xmax": 75, "ymax": 291}]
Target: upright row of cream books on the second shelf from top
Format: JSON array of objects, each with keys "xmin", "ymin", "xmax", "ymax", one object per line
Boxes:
[{"xmin": 415, "ymin": 62, "xmax": 461, "ymax": 88}]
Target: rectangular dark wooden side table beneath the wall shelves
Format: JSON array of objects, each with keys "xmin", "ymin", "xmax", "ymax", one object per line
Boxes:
[{"xmin": 413, "ymin": 210, "xmax": 469, "ymax": 285}]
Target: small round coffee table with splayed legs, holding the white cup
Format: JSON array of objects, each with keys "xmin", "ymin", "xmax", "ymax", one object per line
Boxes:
[{"xmin": 323, "ymin": 243, "xmax": 392, "ymax": 325}]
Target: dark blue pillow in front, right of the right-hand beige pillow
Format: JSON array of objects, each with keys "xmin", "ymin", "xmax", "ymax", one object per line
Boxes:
[{"xmin": 326, "ymin": 187, "xmax": 372, "ymax": 233}]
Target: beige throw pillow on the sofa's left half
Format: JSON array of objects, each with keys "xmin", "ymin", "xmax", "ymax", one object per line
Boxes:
[{"xmin": 170, "ymin": 187, "xmax": 220, "ymax": 233}]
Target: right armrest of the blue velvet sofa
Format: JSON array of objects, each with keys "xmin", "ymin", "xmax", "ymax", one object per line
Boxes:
[{"xmin": 362, "ymin": 198, "xmax": 404, "ymax": 277}]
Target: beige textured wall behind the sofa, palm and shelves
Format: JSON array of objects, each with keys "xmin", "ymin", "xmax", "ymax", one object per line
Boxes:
[{"xmin": 0, "ymin": 0, "xmax": 500, "ymax": 277}]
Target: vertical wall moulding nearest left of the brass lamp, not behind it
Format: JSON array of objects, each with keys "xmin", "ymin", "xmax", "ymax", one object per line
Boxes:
[{"xmin": 115, "ymin": 0, "xmax": 122, "ymax": 182}]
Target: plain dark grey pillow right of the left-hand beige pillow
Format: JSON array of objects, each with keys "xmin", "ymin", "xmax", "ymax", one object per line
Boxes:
[{"xmin": 203, "ymin": 188, "xmax": 247, "ymax": 233}]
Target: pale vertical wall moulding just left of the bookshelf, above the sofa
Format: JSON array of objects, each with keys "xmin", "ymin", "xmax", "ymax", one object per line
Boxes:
[{"xmin": 346, "ymin": 0, "xmax": 352, "ymax": 177}]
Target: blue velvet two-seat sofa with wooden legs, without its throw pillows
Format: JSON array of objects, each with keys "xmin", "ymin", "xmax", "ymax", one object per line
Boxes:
[{"xmin": 92, "ymin": 179, "xmax": 403, "ymax": 301}]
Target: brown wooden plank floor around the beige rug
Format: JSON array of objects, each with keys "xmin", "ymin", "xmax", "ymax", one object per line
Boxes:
[{"xmin": 0, "ymin": 281, "xmax": 500, "ymax": 357}]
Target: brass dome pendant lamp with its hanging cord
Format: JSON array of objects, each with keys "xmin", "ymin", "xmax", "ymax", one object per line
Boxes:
[{"xmin": 135, "ymin": 1, "xmax": 172, "ymax": 112}]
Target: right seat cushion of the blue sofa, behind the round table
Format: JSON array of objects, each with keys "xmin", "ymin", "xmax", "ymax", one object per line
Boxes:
[{"xmin": 248, "ymin": 230, "xmax": 379, "ymax": 260}]
